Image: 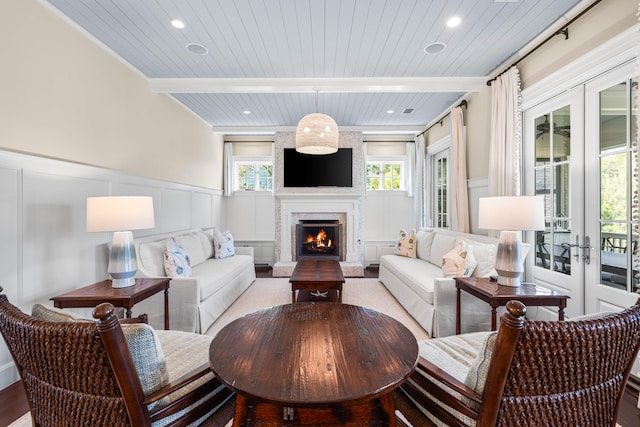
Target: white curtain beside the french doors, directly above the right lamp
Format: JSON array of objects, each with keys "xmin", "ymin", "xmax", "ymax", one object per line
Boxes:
[{"xmin": 489, "ymin": 67, "xmax": 521, "ymax": 196}]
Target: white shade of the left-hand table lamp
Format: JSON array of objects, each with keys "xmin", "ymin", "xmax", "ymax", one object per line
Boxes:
[{"xmin": 87, "ymin": 196, "xmax": 155, "ymax": 232}]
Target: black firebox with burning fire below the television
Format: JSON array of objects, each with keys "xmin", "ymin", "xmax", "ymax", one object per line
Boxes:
[{"xmin": 296, "ymin": 220, "xmax": 342, "ymax": 259}]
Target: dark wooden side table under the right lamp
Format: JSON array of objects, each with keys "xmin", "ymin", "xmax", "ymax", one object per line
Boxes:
[{"xmin": 455, "ymin": 277, "xmax": 569, "ymax": 334}]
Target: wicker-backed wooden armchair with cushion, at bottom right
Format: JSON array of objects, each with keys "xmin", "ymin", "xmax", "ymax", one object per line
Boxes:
[{"xmin": 401, "ymin": 300, "xmax": 640, "ymax": 427}]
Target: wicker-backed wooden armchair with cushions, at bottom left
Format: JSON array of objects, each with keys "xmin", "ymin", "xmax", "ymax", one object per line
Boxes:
[{"xmin": 0, "ymin": 288, "xmax": 233, "ymax": 427}]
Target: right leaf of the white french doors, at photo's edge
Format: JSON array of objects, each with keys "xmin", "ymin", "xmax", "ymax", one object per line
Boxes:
[{"xmin": 585, "ymin": 64, "xmax": 640, "ymax": 313}]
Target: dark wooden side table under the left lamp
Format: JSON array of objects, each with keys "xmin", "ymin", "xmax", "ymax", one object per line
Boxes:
[{"xmin": 51, "ymin": 277, "xmax": 170, "ymax": 330}]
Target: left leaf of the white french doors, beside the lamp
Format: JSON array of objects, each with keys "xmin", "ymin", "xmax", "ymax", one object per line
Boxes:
[{"xmin": 523, "ymin": 87, "xmax": 587, "ymax": 320}]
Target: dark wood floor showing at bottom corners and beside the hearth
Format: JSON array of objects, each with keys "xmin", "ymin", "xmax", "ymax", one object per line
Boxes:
[{"xmin": 0, "ymin": 267, "xmax": 640, "ymax": 427}]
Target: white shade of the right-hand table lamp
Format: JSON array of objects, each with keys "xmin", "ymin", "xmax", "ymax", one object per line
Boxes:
[{"xmin": 478, "ymin": 196, "xmax": 544, "ymax": 231}]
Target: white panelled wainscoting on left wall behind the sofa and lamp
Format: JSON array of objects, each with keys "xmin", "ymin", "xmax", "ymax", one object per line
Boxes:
[{"xmin": 0, "ymin": 151, "xmax": 226, "ymax": 389}]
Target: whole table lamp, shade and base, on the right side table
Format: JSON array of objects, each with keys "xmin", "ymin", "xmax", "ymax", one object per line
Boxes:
[{"xmin": 478, "ymin": 196, "xmax": 544, "ymax": 286}]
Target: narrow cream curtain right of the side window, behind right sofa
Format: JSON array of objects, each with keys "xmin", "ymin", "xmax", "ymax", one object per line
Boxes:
[{"xmin": 451, "ymin": 107, "xmax": 469, "ymax": 233}]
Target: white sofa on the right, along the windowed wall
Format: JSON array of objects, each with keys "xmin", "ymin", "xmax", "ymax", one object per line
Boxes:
[{"xmin": 379, "ymin": 228, "xmax": 498, "ymax": 337}]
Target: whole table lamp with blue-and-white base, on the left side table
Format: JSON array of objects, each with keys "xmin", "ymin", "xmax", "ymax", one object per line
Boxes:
[{"xmin": 87, "ymin": 196, "xmax": 155, "ymax": 288}]
